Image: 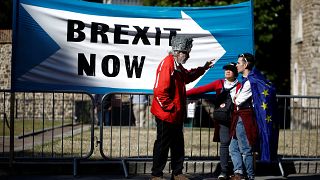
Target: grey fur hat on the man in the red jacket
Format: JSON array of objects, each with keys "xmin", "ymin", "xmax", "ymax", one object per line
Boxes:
[{"xmin": 171, "ymin": 35, "xmax": 193, "ymax": 52}]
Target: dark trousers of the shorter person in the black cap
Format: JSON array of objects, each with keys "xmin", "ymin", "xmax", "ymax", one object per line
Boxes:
[{"xmin": 219, "ymin": 124, "xmax": 230, "ymax": 175}]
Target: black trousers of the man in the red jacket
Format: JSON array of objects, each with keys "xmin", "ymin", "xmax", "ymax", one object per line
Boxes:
[{"xmin": 151, "ymin": 118, "xmax": 184, "ymax": 177}]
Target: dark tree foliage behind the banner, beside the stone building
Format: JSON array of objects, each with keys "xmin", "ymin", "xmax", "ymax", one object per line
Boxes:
[{"xmin": 144, "ymin": 0, "xmax": 290, "ymax": 94}]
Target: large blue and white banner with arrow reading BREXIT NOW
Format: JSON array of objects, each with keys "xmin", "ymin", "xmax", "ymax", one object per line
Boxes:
[{"xmin": 12, "ymin": 0, "xmax": 254, "ymax": 93}]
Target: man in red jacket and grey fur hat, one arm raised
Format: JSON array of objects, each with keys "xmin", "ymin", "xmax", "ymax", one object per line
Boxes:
[{"xmin": 151, "ymin": 36, "xmax": 213, "ymax": 179}]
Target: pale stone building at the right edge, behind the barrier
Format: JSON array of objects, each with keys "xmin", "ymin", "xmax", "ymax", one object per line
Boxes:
[{"xmin": 290, "ymin": 0, "xmax": 320, "ymax": 129}]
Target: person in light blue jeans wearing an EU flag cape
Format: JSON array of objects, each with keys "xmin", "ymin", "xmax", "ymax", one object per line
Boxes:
[{"xmin": 229, "ymin": 53, "xmax": 278, "ymax": 179}]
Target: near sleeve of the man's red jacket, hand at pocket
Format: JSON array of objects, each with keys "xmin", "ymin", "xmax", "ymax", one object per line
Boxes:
[{"xmin": 153, "ymin": 58, "xmax": 174, "ymax": 111}]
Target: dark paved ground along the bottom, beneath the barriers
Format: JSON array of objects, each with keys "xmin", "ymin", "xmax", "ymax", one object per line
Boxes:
[{"xmin": 0, "ymin": 158, "xmax": 320, "ymax": 180}]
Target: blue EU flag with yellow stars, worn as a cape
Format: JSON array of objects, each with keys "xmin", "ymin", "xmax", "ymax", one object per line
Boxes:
[{"xmin": 248, "ymin": 68, "xmax": 279, "ymax": 162}]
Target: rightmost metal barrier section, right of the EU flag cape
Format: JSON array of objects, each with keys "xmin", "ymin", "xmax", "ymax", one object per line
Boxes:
[{"xmin": 277, "ymin": 95, "xmax": 320, "ymax": 160}]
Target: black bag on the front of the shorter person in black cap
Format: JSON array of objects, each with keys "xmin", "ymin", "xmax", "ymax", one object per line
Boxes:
[{"xmin": 213, "ymin": 80, "xmax": 237, "ymax": 126}]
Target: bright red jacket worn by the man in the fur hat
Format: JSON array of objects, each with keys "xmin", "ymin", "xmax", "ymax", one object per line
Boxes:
[{"xmin": 151, "ymin": 54, "xmax": 206, "ymax": 124}]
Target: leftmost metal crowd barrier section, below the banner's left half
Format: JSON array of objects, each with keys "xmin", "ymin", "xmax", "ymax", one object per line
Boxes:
[{"xmin": 0, "ymin": 90, "xmax": 94, "ymax": 174}]
